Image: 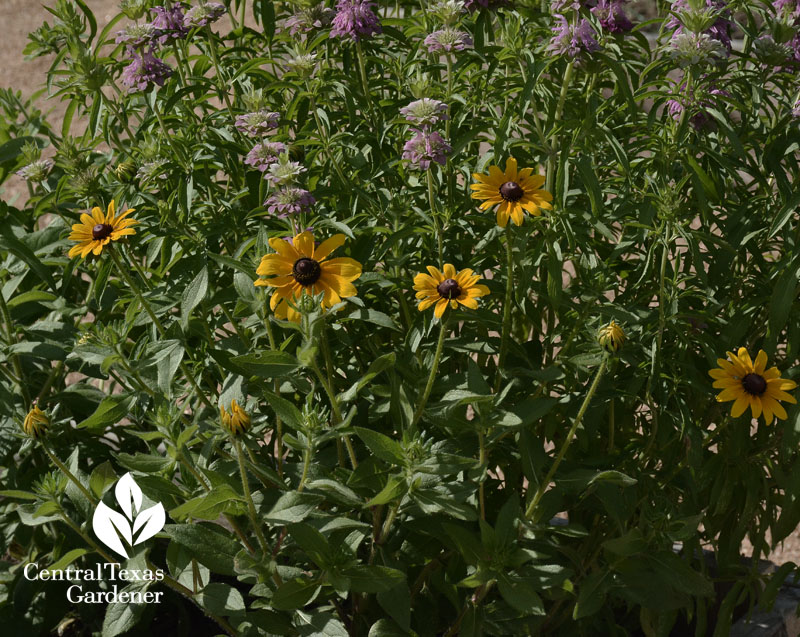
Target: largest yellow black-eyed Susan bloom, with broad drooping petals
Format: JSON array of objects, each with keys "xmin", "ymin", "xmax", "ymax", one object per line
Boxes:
[{"xmin": 255, "ymin": 231, "xmax": 361, "ymax": 323}]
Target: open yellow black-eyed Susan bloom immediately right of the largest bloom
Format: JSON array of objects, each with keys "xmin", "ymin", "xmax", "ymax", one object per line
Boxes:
[{"xmin": 414, "ymin": 263, "xmax": 489, "ymax": 318}]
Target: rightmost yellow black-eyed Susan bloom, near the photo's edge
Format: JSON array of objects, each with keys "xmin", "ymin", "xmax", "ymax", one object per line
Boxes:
[{"xmin": 708, "ymin": 347, "xmax": 797, "ymax": 425}]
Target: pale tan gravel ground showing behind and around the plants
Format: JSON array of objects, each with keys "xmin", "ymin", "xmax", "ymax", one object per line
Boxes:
[{"xmin": 0, "ymin": 0, "xmax": 800, "ymax": 564}]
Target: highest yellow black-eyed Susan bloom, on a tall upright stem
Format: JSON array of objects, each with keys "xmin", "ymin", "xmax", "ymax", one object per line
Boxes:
[{"xmin": 470, "ymin": 157, "xmax": 553, "ymax": 228}]
